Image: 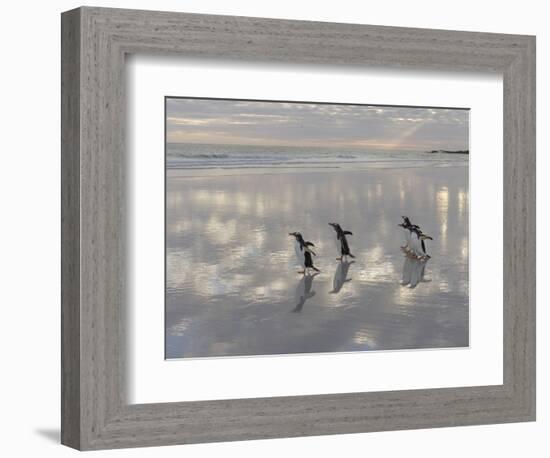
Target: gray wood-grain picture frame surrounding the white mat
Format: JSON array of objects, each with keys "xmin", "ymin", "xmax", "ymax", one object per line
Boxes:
[{"xmin": 61, "ymin": 7, "xmax": 535, "ymax": 450}]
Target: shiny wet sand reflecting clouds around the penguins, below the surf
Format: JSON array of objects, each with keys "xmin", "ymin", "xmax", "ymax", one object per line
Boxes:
[{"xmin": 166, "ymin": 166, "xmax": 469, "ymax": 358}]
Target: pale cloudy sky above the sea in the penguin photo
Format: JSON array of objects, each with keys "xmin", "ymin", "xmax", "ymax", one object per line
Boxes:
[{"xmin": 166, "ymin": 98, "xmax": 469, "ymax": 150}]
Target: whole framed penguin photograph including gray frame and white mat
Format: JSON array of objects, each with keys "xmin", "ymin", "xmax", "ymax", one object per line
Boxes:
[{"xmin": 62, "ymin": 7, "xmax": 535, "ymax": 450}]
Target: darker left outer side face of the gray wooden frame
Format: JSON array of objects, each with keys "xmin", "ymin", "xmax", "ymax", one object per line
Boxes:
[{"xmin": 61, "ymin": 11, "xmax": 81, "ymax": 448}]
